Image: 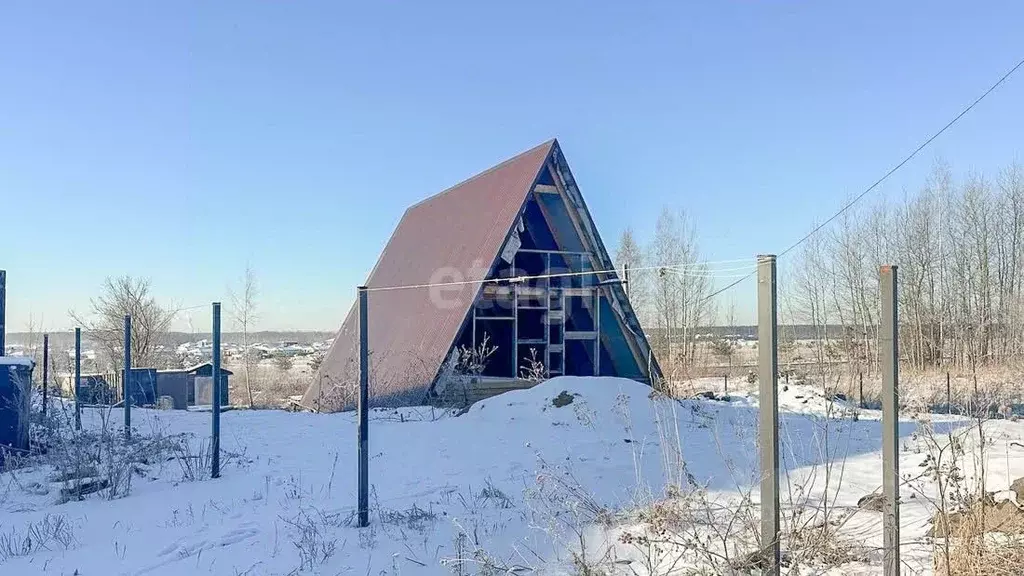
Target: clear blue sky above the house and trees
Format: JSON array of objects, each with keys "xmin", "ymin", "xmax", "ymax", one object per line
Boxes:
[{"xmin": 0, "ymin": 0, "xmax": 1024, "ymax": 331}]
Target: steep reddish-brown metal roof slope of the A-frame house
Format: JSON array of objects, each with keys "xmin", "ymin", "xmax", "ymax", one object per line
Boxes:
[{"xmin": 302, "ymin": 139, "xmax": 557, "ymax": 410}]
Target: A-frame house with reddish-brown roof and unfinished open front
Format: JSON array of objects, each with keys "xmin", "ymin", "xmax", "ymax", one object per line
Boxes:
[{"xmin": 302, "ymin": 139, "xmax": 660, "ymax": 411}]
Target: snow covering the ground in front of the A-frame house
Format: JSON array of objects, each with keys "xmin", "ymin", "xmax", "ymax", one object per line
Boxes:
[{"xmin": 0, "ymin": 377, "xmax": 1024, "ymax": 576}]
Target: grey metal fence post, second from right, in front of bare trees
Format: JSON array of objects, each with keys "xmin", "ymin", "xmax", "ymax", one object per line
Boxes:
[{"xmin": 758, "ymin": 255, "xmax": 781, "ymax": 576}]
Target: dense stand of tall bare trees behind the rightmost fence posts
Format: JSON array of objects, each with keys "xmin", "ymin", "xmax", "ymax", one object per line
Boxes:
[{"xmin": 780, "ymin": 163, "xmax": 1024, "ymax": 369}]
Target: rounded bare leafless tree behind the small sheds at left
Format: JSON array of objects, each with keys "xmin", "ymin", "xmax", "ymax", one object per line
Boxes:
[{"xmin": 70, "ymin": 276, "xmax": 175, "ymax": 370}]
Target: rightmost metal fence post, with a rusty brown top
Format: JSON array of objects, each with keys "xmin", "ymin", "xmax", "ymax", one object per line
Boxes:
[{"xmin": 880, "ymin": 265, "xmax": 899, "ymax": 576}]
